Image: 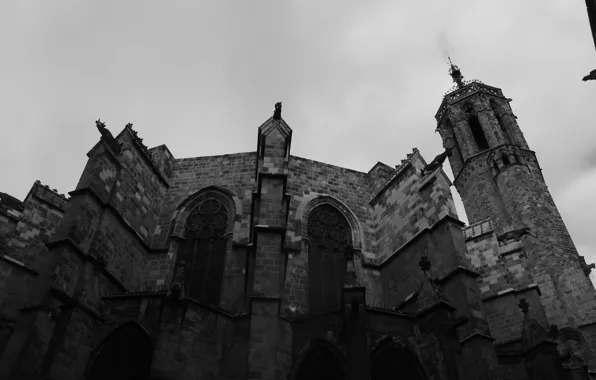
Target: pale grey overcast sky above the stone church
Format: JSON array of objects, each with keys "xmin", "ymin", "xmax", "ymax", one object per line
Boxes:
[{"xmin": 0, "ymin": 0, "xmax": 596, "ymax": 274}]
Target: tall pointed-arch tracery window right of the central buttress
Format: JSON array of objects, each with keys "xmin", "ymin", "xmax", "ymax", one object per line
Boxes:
[{"xmin": 308, "ymin": 205, "xmax": 352, "ymax": 313}]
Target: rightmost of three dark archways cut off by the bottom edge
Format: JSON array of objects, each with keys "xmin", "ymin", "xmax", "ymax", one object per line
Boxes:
[{"xmin": 370, "ymin": 339, "xmax": 427, "ymax": 380}]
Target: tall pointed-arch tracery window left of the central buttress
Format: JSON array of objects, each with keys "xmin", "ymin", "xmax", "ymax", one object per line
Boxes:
[{"xmin": 182, "ymin": 196, "xmax": 230, "ymax": 305}]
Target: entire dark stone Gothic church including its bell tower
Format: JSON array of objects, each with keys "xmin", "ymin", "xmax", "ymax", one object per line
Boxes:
[{"xmin": 0, "ymin": 66, "xmax": 596, "ymax": 380}]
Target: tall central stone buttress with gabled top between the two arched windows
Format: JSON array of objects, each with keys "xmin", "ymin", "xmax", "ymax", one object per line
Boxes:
[{"xmin": 247, "ymin": 110, "xmax": 292, "ymax": 380}]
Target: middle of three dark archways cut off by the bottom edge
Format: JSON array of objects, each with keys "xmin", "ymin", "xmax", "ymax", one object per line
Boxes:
[{"xmin": 294, "ymin": 341, "xmax": 347, "ymax": 380}]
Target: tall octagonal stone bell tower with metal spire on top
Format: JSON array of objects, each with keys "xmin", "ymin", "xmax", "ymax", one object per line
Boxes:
[{"xmin": 435, "ymin": 60, "xmax": 596, "ymax": 340}]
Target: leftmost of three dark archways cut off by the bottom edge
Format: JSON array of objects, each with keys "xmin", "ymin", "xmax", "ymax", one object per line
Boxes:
[{"xmin": 86, "ymin": 322, "xmax": 153, "ymax": 380}]
